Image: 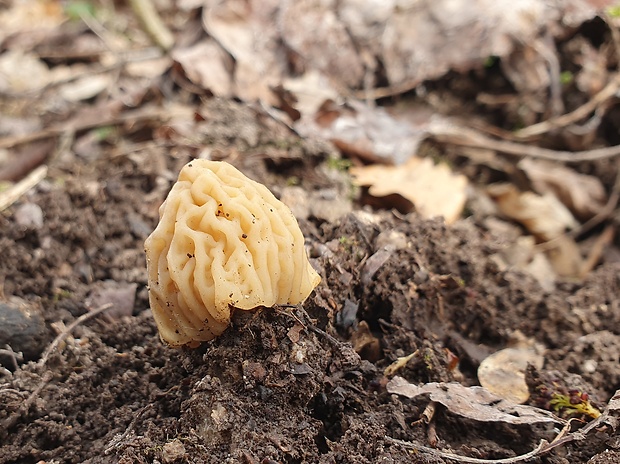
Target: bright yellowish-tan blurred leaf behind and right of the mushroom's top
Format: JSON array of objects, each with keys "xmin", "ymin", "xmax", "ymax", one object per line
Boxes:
[{"xmin": 350, "ymin": 158, "xmax": 467, "ymax": 224}]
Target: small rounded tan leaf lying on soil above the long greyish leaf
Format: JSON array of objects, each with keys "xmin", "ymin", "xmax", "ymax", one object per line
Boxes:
[{"xmin": 478, "ymin": 347, "xmax": 544, "ymax": 403}]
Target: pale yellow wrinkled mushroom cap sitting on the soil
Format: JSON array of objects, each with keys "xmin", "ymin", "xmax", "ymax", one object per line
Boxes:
[{"xmin": 145, "ymin": 159, "xmax": 321, "ymax": 347}]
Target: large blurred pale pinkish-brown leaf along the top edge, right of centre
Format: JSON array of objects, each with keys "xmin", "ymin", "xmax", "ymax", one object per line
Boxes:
[{"xmin": 358, "ymin": 0, "xmax": 605, "ymax": 86}]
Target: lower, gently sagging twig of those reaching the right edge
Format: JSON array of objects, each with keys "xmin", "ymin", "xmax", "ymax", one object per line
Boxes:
[{"xmin": 429, "ymin": 121, "xmax": 620, "ymax": 163}]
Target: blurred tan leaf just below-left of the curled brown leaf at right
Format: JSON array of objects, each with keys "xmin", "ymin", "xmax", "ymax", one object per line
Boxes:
[{"xmin": 487, "ymin": 184, "xmax": 579, "ymax": 241}]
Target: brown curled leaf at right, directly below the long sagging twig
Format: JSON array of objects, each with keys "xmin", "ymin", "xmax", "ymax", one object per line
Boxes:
[{"xmin": 519, "ymin": 158, "xmax": 606, "ymax": 219}]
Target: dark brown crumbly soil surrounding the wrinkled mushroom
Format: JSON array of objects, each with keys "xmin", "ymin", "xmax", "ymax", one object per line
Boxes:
[{"xmin": 0, "ymin": 100, "xmax": 620, "ymax": 464}]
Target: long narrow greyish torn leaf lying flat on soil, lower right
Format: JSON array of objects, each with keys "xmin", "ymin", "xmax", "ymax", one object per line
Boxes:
[{"xmin": 387, "ymin": 376, "xmax": 562, "ymax": 424}]
